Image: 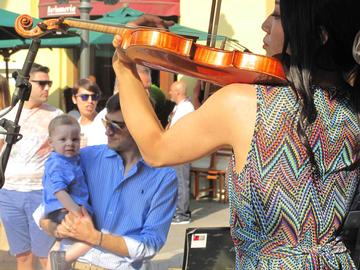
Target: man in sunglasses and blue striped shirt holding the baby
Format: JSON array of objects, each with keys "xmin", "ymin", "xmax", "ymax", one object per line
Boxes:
[{"xmin": 41, "ymin": 94, "xmax": 177, "ymax": 270}]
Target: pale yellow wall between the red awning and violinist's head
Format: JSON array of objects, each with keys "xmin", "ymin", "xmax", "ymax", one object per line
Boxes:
[{"xmin": 180, "ymin": 0, "xmax": 274, "ymax": 94}]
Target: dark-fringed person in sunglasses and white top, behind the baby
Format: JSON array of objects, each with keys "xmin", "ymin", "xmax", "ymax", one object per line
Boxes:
[{"xmin": 72, "ymin": 79, "xmax": 107, "ymax": 147}]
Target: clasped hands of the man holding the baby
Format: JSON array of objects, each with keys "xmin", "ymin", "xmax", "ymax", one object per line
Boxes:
[{"xmin": 57, "ymin": 207, "xmax": 100, "ymax": 245}]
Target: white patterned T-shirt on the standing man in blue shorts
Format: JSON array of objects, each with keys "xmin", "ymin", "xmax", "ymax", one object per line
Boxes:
[{"xmin": 1, "ymin": 103, "xmax": 63, "ymax": 192}]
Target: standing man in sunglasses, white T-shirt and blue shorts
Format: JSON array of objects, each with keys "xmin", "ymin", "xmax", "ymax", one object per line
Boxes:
[{"xmin": 0, "ymin": 64, "xmax": 63, "ymax": 270}]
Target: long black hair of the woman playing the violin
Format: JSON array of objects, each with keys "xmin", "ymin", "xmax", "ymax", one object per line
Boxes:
[{"xmin": 280, "ymin": 0, "xmax": 360, "ymax": 173}]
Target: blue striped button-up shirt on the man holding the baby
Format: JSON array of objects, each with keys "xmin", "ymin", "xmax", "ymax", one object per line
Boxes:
[{"xmin": 80, "ymin": 145, "xmax": 177, "ymax": 261}]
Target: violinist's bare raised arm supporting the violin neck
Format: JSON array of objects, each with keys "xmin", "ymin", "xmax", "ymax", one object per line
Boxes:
[{"xmin": 113, "ymin": 41, "xmax": 256, "ymax": 171}]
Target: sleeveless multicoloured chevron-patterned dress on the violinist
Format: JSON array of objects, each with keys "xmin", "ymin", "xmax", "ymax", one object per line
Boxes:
[{"xmin": 228, "ymin": 86, "xmax": 360, "ymax": 270}]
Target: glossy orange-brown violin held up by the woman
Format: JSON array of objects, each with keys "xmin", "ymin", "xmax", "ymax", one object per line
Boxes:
[{"xmin": 15, "ymin": 15, "xmax": 287, "ymax": 86}]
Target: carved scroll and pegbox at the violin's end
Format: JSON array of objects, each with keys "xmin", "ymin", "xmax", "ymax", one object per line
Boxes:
[{"xmin": 14, "ymin": 14, "xmax": 69, "ymax": 38}]
